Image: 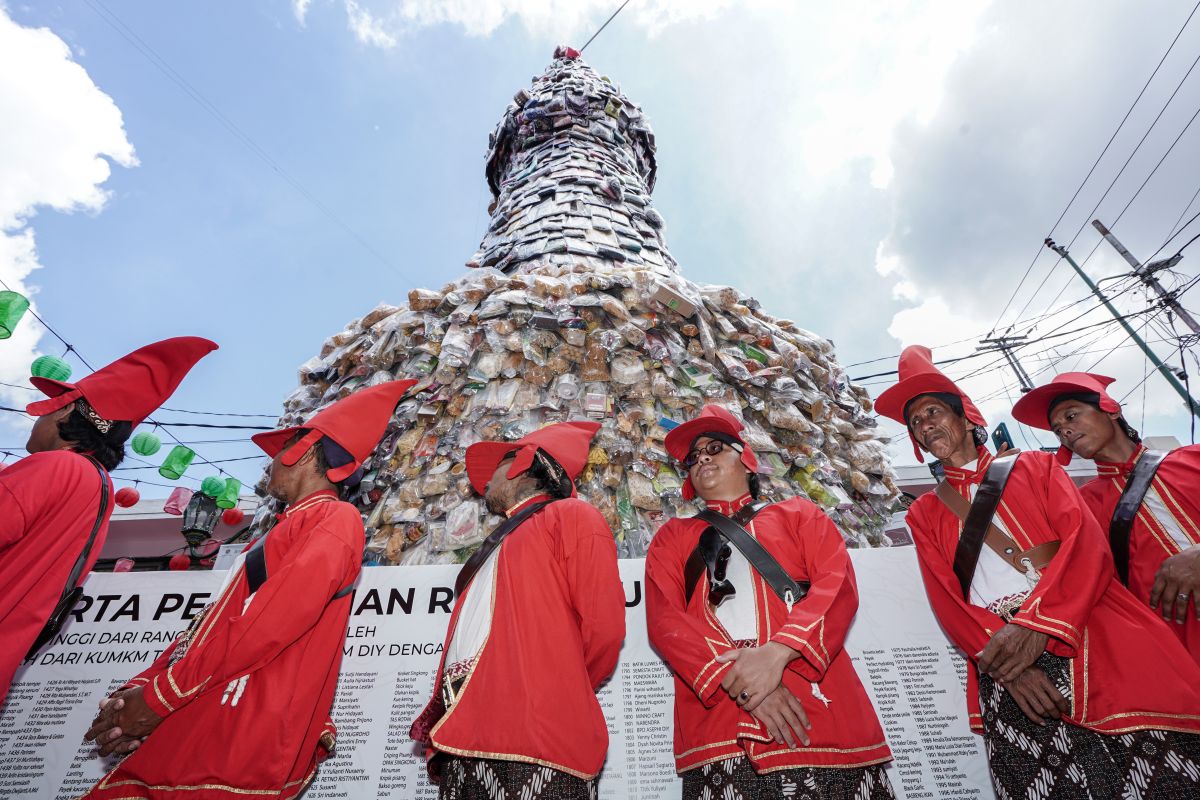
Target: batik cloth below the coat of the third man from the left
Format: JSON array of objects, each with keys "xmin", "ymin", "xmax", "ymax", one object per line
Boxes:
[{"xmin": 438, "ymin": 756, "xmax": 596, "ymax": 800}]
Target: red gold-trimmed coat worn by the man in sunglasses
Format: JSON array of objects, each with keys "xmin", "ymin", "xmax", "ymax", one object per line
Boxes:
[{"xmin": 646, "ymin": 495, "xmax": 892, "ymax": 772}]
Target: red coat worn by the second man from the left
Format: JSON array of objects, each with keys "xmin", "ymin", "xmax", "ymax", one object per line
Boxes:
[{"xmin": 84, "ymin": 492, "xmax": 364, "ymax": 800}]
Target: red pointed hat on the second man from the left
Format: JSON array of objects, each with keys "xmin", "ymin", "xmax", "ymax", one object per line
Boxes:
[{"xmin": 251, "ymin": 380, "xmax": 416, "ymax": 483}]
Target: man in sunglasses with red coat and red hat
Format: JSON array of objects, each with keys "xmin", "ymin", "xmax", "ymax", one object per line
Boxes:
[{"xmin": 646, "ymin": 405, "xmax": 895, "ymax": 800}]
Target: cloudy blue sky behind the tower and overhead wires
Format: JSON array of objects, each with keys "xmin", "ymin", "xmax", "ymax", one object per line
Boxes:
[{"xmin": 0, "ymin": 0, "xmax": 1200, "ymax": 495}]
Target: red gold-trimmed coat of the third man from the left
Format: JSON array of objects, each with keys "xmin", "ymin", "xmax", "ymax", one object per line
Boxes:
[{"xmin": 413, "ymin": 495, "xmax": 625, "ymax": 778}]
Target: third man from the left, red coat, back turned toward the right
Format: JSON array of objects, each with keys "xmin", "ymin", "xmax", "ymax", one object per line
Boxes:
[{"xmin": 410, "ymin": 422, "xmax": 625, "ymax": 800}]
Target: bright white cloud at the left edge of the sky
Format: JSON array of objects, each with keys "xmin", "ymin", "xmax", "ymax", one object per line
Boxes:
[{"xmin": 0, "ymin": 6, "xmax": 138, "ymax": 431}]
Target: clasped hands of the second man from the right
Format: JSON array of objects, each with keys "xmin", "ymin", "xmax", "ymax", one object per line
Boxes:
[{"xmin": 976, "ymin": 625, "xmax": 1070, "ymax": 724}]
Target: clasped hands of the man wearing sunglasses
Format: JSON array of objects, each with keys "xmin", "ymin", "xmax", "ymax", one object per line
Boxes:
[{"xmin": 716, "ymin": 642, "xmax": 812, "ymax": 747}]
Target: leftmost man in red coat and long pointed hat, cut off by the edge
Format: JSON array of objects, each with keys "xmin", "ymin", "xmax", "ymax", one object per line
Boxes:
[{"xmin": 0, "ymin": 336, "xmax": 217, "ymax": 704}]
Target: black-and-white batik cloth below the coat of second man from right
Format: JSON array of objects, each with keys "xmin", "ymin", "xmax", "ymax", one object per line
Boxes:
[{"xmin": 979, "ymin": 654, "xmax": 1200, "ymax": 800}]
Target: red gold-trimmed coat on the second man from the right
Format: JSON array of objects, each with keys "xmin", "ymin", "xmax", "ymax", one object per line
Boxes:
[{"xmin": 908, "ymin": 449, "xmax": 1200, "ymax": 733}]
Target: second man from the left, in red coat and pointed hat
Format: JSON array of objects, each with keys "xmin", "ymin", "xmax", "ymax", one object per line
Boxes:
[{"xmin": 84, "ymin": 380, "xmax": 415, "ymax": 800}]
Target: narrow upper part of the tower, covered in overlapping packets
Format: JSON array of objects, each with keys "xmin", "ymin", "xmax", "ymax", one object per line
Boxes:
[{"xmin": 468, "ymin": 47, "xmax": 676, "ymax": 278}]
